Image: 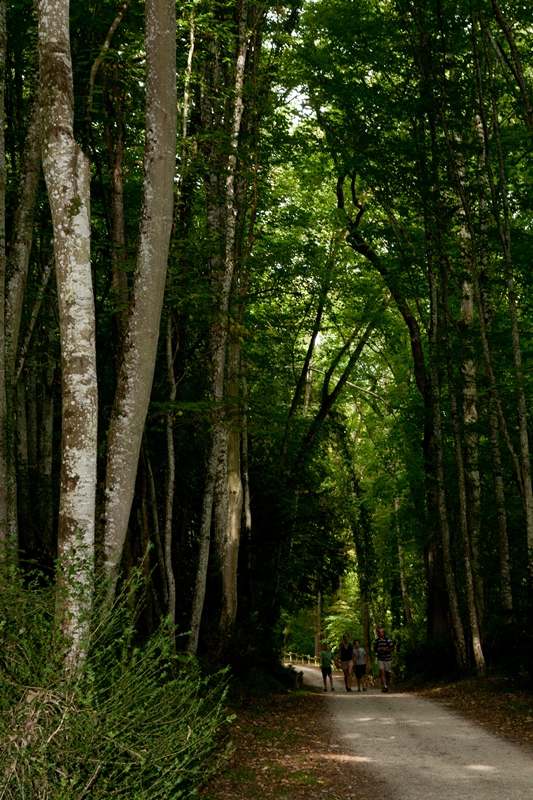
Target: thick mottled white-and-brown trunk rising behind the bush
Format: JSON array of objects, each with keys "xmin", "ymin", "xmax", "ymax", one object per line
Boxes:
[{"xmin": 38, "ymin": 0, "xmax": 98, "ymax": 669}]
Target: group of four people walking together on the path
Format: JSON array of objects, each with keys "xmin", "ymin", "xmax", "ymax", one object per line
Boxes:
[{"xmin": 321, "ymin": 628, "xmax": 394, "ymax": 692}]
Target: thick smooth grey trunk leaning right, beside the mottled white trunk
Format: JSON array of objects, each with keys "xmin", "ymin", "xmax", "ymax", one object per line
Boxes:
[{"xmin": 104, "ymin": 0, "xmax": 176, "ymax": 591}]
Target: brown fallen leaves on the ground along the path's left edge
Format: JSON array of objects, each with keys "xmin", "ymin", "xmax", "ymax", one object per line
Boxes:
[{"xmin": 202, "ymin": 691, "xmax": 387, "ymax": 800}]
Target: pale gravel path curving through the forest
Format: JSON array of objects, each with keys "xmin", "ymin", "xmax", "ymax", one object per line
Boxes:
[{"xmin": 297, "ymin": 667, "xmax": 533, "ymax": 800}]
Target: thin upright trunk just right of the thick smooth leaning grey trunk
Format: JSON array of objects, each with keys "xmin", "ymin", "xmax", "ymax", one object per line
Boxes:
[{"xmin": 165, "ymin": 314, "xmax": 176, "ymax": 637}]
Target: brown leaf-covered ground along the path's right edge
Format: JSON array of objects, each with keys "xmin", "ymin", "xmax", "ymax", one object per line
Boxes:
[{"xmin": 417, "ymin": 678, "xmax": 533, "ymax": 746}]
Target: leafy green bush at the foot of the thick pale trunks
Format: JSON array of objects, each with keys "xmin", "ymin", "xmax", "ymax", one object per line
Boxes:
[{"xmin": 0, "ymin": 582, "xmax": 229, "ymax": 800}]
